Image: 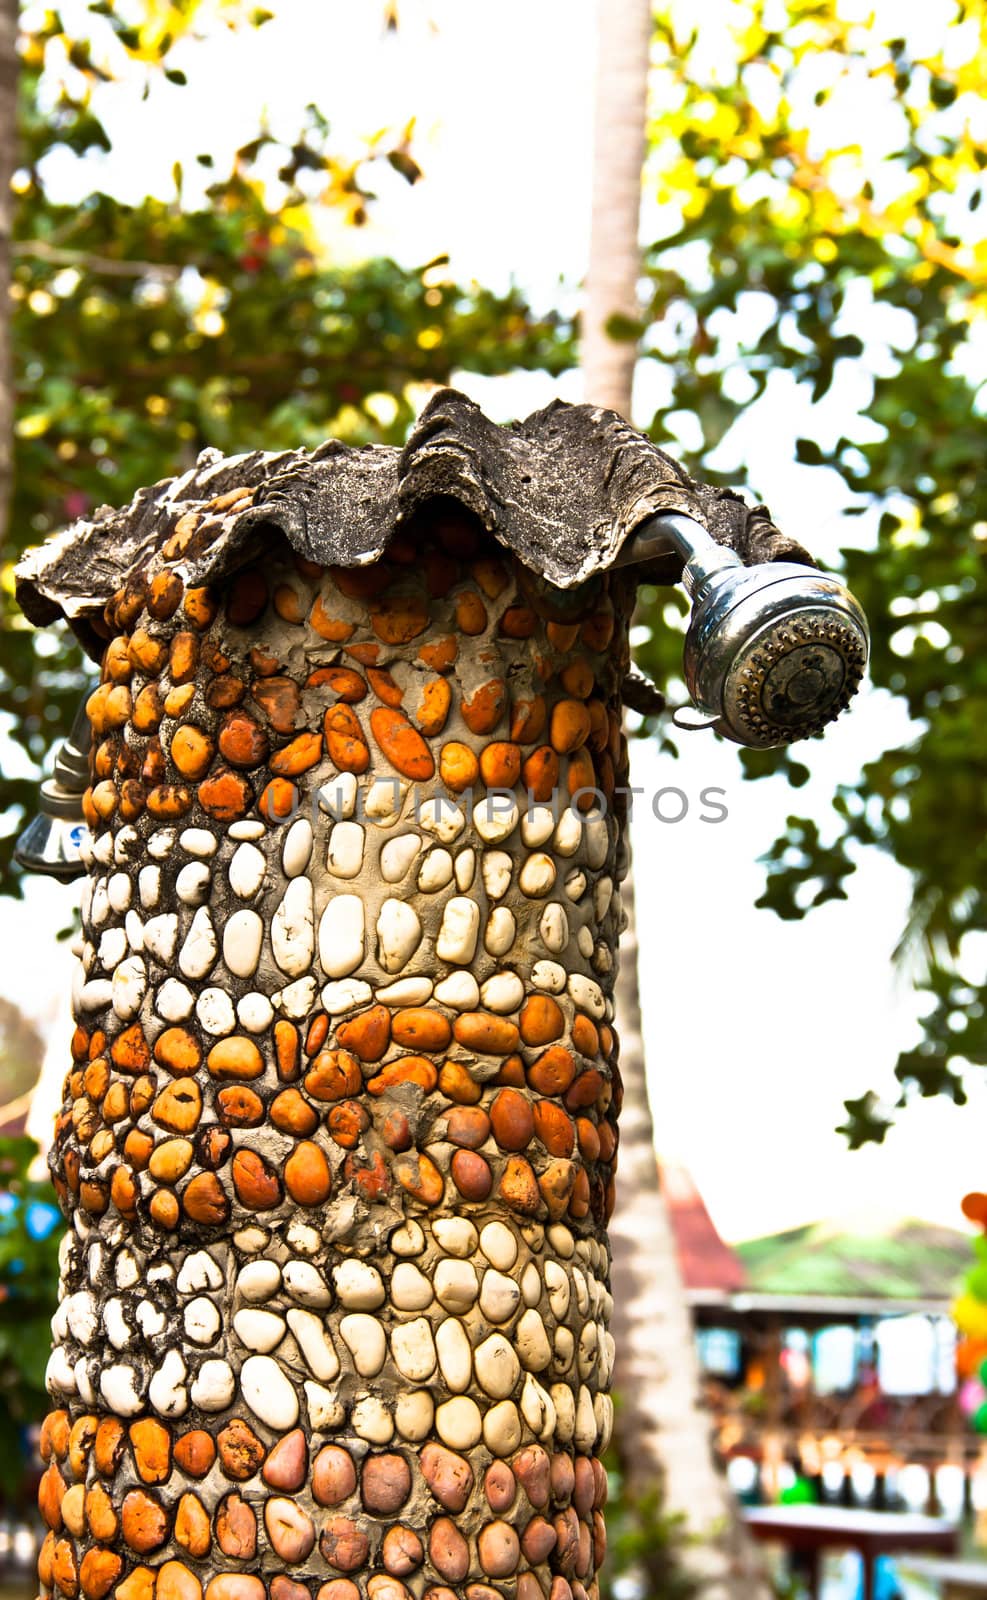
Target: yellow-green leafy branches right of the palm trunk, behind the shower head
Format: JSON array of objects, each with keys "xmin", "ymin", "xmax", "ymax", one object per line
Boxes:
[{"xmin": 624, "ymin": 0, "xmax": 987, "ymax": 1144}]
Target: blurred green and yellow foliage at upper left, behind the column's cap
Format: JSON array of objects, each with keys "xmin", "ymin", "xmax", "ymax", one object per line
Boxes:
[{"xmin": 0, "ymin": 0, "xmax": 574, "ymax": 894}]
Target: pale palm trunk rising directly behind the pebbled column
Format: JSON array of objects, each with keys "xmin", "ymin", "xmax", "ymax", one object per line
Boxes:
[{"xmin": 582, "ymin": 0, "xmax": 768, "ymax": 1600}]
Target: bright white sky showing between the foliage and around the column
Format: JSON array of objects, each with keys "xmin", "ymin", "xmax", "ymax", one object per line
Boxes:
[{"xmin": 7, "ymin": 0, "xmax": 987, "ymax": 1240}]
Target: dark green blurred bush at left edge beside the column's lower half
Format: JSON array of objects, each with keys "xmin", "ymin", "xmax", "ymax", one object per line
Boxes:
[{"xmin": 0, "ymin": 1138, "xmax": 61, "ymax": 1494}]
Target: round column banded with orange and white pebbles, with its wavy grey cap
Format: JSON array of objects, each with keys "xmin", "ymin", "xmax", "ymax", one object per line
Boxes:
[{"xmin": 13, "ymin": 387, "xmax": 809, "ymax": 1600}]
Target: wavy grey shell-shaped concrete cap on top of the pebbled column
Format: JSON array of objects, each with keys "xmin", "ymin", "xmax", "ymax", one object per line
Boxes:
[{"xmin": 18, "ymin": 389, "xmax": 809, "ymax": 658}]
